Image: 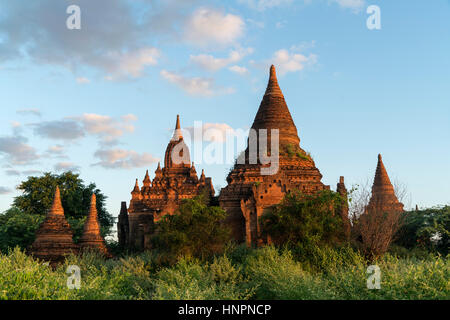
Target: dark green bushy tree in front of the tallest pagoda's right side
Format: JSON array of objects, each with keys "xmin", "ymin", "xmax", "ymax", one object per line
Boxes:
[{"xmin": 262, "ymin": 190, "xmax": 345, "ymax": 247}]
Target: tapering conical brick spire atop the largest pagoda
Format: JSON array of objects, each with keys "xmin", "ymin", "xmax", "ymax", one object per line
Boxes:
[{"xmin": 252, "ymin": 65, "xmax": 300, "ymax": 150}]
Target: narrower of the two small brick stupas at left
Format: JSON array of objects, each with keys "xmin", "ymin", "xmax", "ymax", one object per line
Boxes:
[{"xmin": 79, "ymin": 193, "xmax": 111, "ymax": 257}]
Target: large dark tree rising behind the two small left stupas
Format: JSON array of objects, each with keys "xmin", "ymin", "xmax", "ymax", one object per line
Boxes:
[{"xmin": 13, "ymin": 171, "xmax": 114, "ymax": 242}]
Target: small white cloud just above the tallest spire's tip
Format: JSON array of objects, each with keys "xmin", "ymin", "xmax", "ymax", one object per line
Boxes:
[{"xmin": 269, "ymin": 49, "xmax": 317, "ymax": 75}]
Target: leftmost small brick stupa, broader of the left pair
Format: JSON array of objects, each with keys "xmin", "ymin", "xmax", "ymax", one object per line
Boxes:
[{"xmin": 29, "ymin": 187, "xmax": 79, "ymax": 266}]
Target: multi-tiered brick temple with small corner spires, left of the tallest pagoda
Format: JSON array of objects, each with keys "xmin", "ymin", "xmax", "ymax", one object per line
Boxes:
[{"xmin": 122, "ymin": 115, "xmax": 214, "ymax": 249}]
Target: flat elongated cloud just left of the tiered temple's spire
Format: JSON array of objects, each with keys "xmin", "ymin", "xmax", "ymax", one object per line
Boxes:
[{"xmin": 93, "ymin": 149, "xmax": 159, "ymax": 169}]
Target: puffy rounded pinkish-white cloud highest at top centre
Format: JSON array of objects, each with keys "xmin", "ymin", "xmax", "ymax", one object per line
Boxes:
[{"xmin": 184, "ymin": 8, "xmax": 245, "ymax": 47}]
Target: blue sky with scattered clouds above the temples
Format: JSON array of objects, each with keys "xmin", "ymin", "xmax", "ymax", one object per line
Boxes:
[{"xmin": 0, "ymin": 0, "xmax": 450, "ymax": 224}]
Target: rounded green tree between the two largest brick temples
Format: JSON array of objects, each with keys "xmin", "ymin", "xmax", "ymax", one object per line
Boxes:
[{"xmin": 151, "ymin": 196, "xmax": 231, "ymax": 259}]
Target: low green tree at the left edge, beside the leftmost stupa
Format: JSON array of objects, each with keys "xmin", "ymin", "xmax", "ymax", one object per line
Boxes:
[{"xmin": 0, "ymin": 207, "xmax": 44, "ymax": 253}]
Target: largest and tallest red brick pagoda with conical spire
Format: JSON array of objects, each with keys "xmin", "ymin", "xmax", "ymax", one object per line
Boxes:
[{"xmin": 219, "ymin": 65, "xmax": 332, "ymax": 246}]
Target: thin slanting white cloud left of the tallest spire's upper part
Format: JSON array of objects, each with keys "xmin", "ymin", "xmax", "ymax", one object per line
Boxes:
[{"xmin": 161, "ymin": 70, "xmax": 234, "ymax": 97}]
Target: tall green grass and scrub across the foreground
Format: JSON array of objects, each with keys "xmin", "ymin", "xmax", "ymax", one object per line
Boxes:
[{"xmin": 0, "ymin": 246, "xmax": 450, "ymax": 300}]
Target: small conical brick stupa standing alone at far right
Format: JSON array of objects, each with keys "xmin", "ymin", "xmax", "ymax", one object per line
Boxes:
[{"xmin": 365, "ymin": 154, "xmax": 403, "ymax": 214}]
